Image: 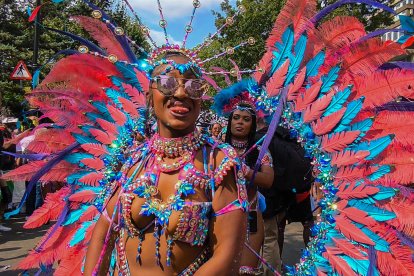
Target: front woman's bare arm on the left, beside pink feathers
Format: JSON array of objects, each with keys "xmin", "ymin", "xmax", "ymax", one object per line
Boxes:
[{"xmin": 84, "ymin": 192, "xmax": 118, "ymax": 276}]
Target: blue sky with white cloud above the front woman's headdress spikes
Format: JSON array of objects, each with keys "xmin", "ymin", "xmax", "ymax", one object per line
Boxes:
[{"xmin": 130, "ymin": 0, "xmax": 235, "ymax": 47}]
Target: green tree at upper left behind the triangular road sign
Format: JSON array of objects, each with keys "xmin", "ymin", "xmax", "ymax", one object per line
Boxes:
[{"xmin": 0, "ymin": 0, "xmax": 146, "ymax": 116}]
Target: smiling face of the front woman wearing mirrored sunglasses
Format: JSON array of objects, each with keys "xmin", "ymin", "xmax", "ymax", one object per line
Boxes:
[{"xmin": 151, "ymin": 56, "xmax": 201, "ymax": 137}]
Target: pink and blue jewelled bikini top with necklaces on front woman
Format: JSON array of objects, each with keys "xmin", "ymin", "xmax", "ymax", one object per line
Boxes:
[{"xmin": 113, "ymin": 132, "xmax": 248, "ymax": 267}]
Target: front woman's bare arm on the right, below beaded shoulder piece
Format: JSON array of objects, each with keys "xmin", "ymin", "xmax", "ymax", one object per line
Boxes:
[{"xmin": 195, "ymin": 151, "xmax": 247, "ymax": 276}]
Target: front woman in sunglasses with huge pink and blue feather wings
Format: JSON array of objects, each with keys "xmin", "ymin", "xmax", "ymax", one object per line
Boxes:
[{"xmin": 4, "ymin": 0, "xmax": 414, "ymax": 275}]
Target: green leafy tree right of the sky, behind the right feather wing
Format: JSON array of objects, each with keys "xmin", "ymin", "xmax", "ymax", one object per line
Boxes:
[{"xmin": 200, "ymin": 0, "xmax": 393, "ymax": 88}]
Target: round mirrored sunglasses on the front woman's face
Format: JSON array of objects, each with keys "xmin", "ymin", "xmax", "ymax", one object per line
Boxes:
[{"xmin": 153, "ymin": 75, "xmax": 207, "ymax": 100}]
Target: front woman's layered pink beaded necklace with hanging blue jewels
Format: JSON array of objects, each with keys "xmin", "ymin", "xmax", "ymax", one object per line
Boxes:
[{"xmin": 123, "ymin": 131, "xmax": 207, "ymax": 266}]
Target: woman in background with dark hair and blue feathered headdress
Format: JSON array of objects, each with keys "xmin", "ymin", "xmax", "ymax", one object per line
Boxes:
[{"xmin": 213, "ymin": 93, "xmax": 274, "ymax": 275}]
